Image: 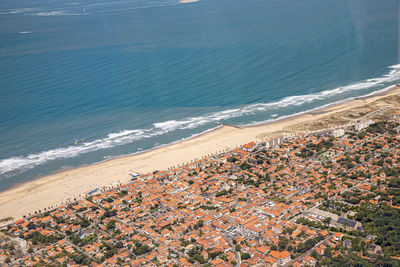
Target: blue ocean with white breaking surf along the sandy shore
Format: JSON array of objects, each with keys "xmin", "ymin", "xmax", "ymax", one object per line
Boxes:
[{"xmin": 0, "ymin": 0, "xmax": 400, "ymax": 191}]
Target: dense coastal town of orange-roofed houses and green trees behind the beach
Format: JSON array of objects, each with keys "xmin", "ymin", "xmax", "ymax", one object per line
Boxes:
[{"xmin": 0, "ymin": 113, "xmax": 400, "ymax": 266}]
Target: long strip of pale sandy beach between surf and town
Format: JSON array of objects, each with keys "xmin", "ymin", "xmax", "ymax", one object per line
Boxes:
[{"xmin": 0, "ymin": 86, "xmax": 400, "ymax": 223}]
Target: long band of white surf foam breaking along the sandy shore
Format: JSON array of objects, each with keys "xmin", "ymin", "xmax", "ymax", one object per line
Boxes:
[{"xmin": 0, "ymin": 64, "xmax": 400, "ymax": 178}]
